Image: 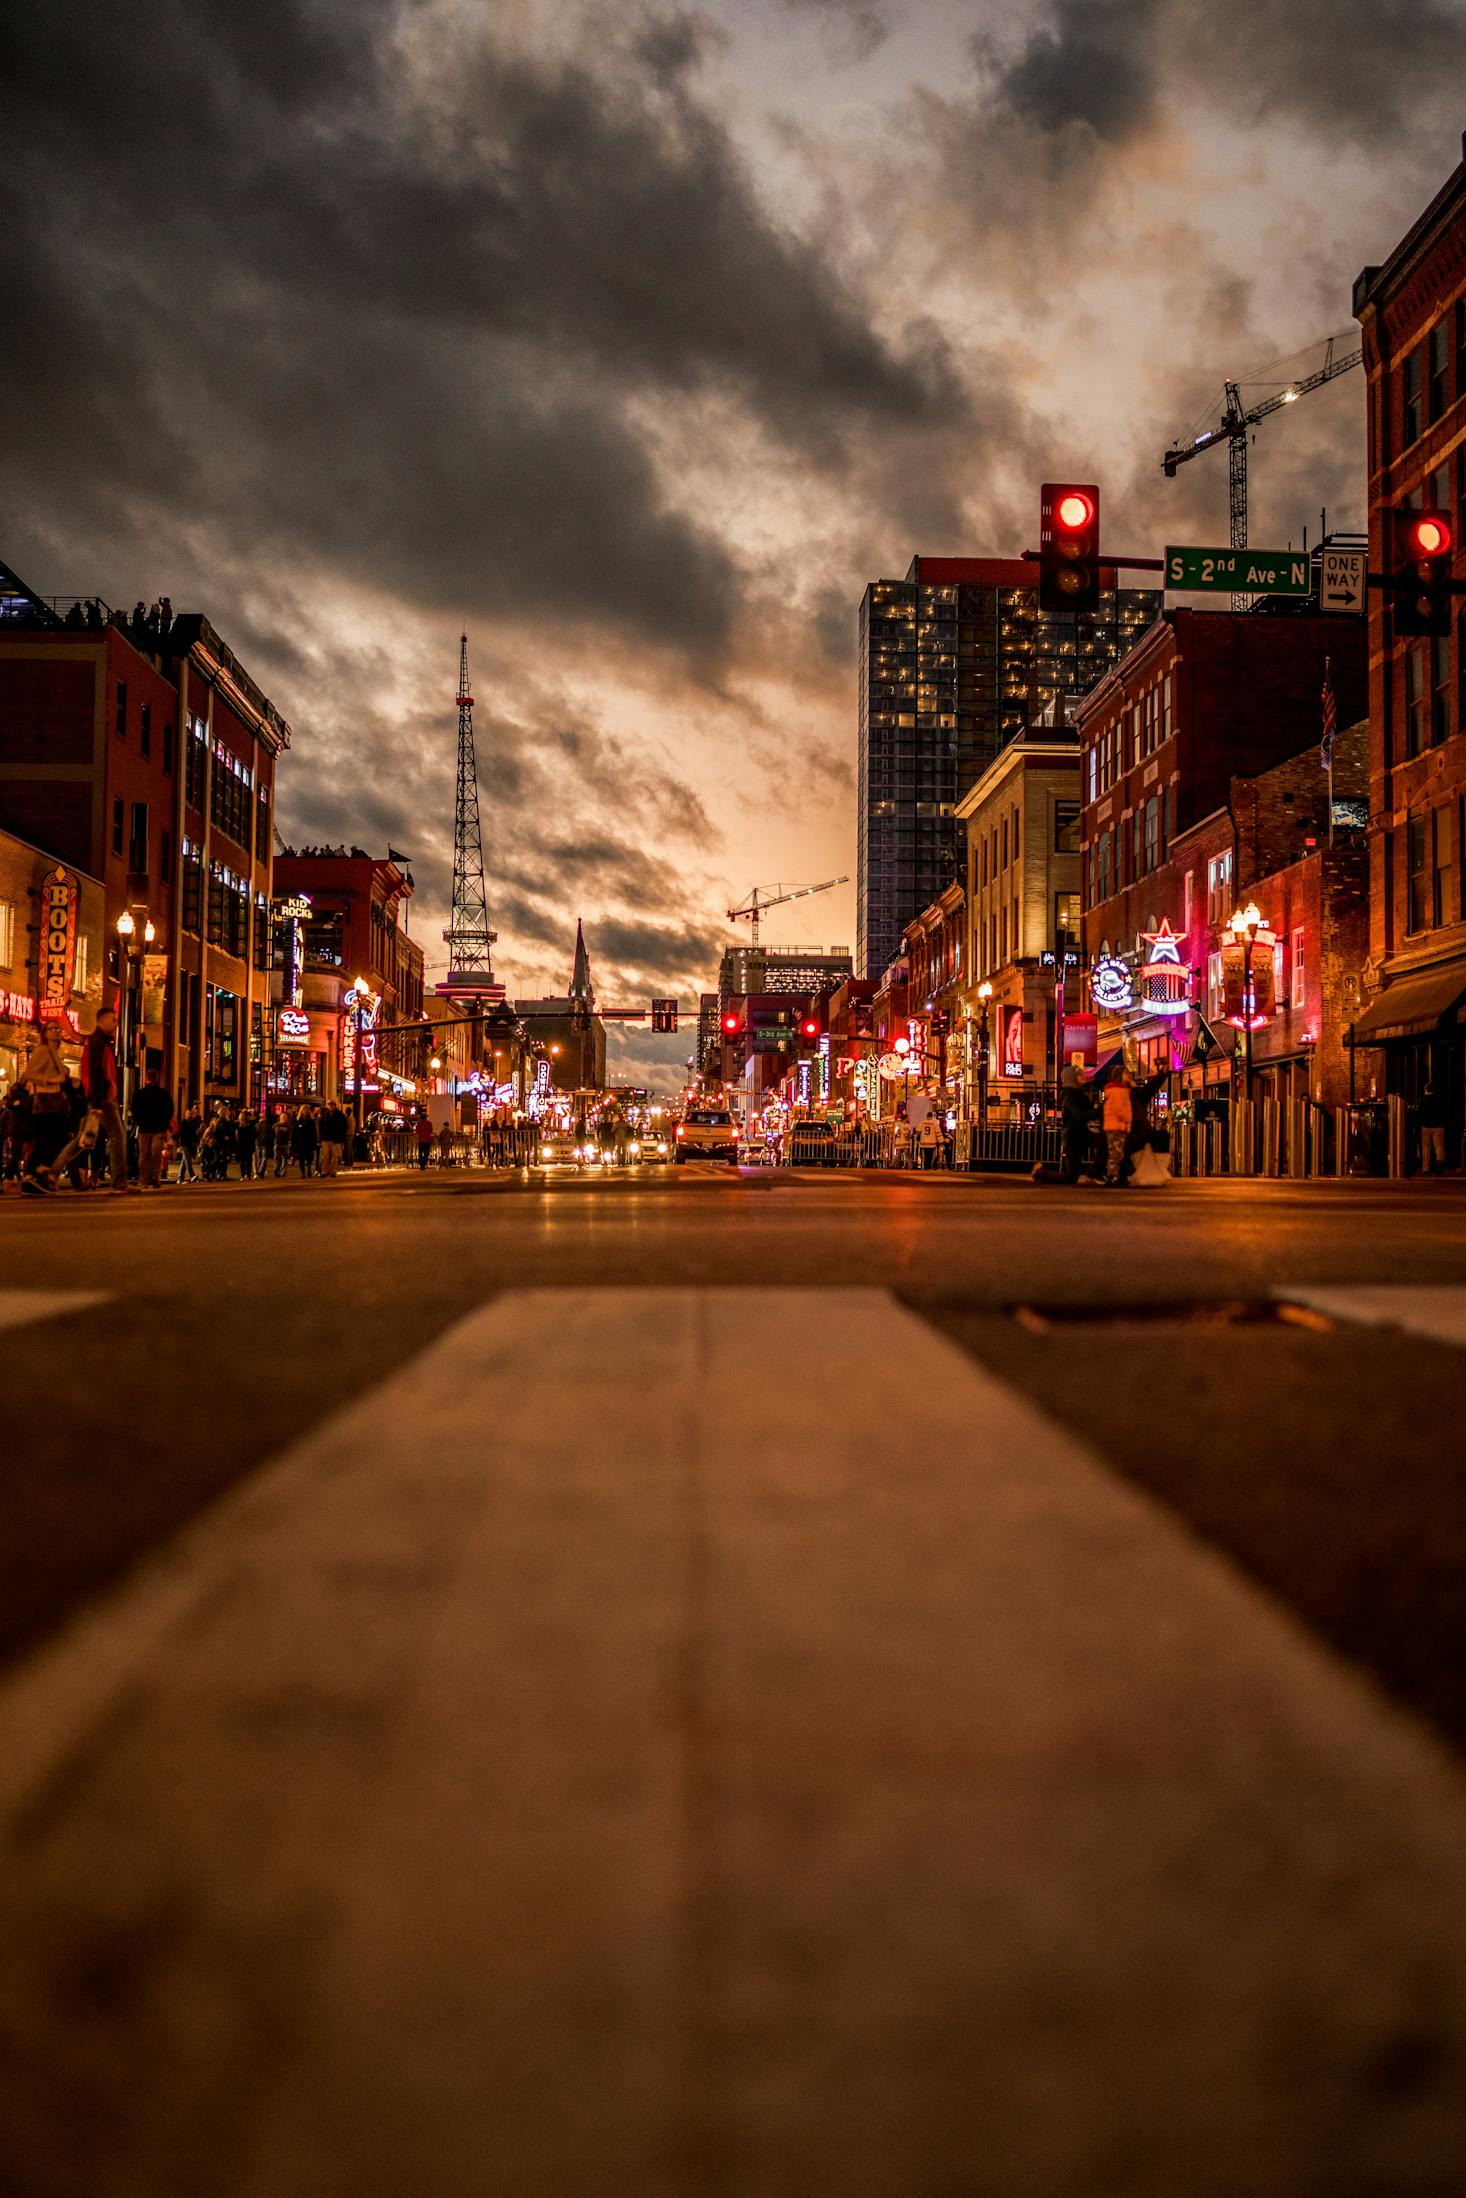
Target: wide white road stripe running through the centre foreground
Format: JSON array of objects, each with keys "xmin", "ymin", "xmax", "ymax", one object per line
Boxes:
[{"xmin": 0, "ymin": 1288, "xmax": 1466, "ymax": 2198}]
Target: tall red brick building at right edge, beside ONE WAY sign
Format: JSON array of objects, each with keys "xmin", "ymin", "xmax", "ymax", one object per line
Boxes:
[{"xmin": 1354, "ymin": 137, "xmax": 1466, "ymax": 1163}]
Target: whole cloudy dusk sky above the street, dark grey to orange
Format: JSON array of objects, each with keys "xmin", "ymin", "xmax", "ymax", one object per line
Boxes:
[{"xmin": 0, "ymin": 0, "xmax": 1466, "ymax": 1079}]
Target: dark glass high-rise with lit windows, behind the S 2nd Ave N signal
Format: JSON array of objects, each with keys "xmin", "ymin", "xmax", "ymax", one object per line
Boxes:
[{"xmin": 855, "ymin": 556, "xmax": 1160, "ymax": 976}]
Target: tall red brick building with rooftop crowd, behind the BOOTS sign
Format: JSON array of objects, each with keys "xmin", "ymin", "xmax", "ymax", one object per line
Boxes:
[{"xmin": 0, "ymin": 569, "xmax": 290, "ymax": 1103}]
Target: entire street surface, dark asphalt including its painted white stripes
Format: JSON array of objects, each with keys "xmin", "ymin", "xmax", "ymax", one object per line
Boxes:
[{"xmin": 0, "ymin": 1169, "xmax": 1466, "ymax": 2198}]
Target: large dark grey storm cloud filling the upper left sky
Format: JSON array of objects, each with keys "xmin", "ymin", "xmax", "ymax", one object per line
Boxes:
[{"xmin": 0, "ymin": 0, "xmax": 960, "ymax": 666}]
